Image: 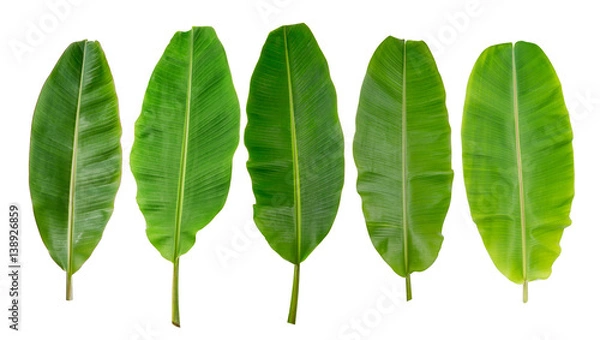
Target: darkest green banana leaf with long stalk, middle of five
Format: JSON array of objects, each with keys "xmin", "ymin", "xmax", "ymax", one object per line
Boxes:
[{"xmin": 245, "ymin": 24, "xmax": 344, "ymax": 323}]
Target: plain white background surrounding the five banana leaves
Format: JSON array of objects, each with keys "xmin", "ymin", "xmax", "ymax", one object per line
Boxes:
[{"xmin": 0, "ymin": 0, "xmax": 600, "ymax": 340}]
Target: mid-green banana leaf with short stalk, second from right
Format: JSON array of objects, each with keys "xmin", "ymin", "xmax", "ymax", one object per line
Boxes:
[{"xmin": 354, "ymin": 37, "xmax": 453, "ymax": 300}]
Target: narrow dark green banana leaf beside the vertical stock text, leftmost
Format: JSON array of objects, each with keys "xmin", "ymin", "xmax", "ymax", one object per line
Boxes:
[{"xmin": 29, "ymin": 40, "xmax": 121, "ymax": 300}]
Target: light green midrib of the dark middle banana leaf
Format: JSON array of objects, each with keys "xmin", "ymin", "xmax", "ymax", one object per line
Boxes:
[{"xmin": 283, "ymin": 26, "xmax": 302, "ymax": 264}]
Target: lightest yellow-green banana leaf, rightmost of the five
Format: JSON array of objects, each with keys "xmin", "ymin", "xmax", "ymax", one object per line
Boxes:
[{"xmin": 462, "ymin": 41, "xmax": 574, "ymax": 302}]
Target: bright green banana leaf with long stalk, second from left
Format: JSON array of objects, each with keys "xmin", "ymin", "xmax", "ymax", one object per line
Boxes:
[{"xmin": 131, "ymin": 27, "xmax": 240, "ymax": 327}]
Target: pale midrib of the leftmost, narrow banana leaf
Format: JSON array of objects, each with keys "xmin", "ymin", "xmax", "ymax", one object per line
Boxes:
[{"xmin": 67, "ymin": 40, "xmax": 87, "ymax": 275}]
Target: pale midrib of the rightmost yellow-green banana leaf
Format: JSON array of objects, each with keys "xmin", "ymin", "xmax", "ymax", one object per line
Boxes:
[{"xmin": 511, "ymin": 45, "xmax": 527, "ymax": 284}]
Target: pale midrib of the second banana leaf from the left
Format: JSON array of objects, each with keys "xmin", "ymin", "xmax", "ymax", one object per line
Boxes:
[{"xmin": 173, "ymin": 28, "xmax": 194, "ymax": 263}]
